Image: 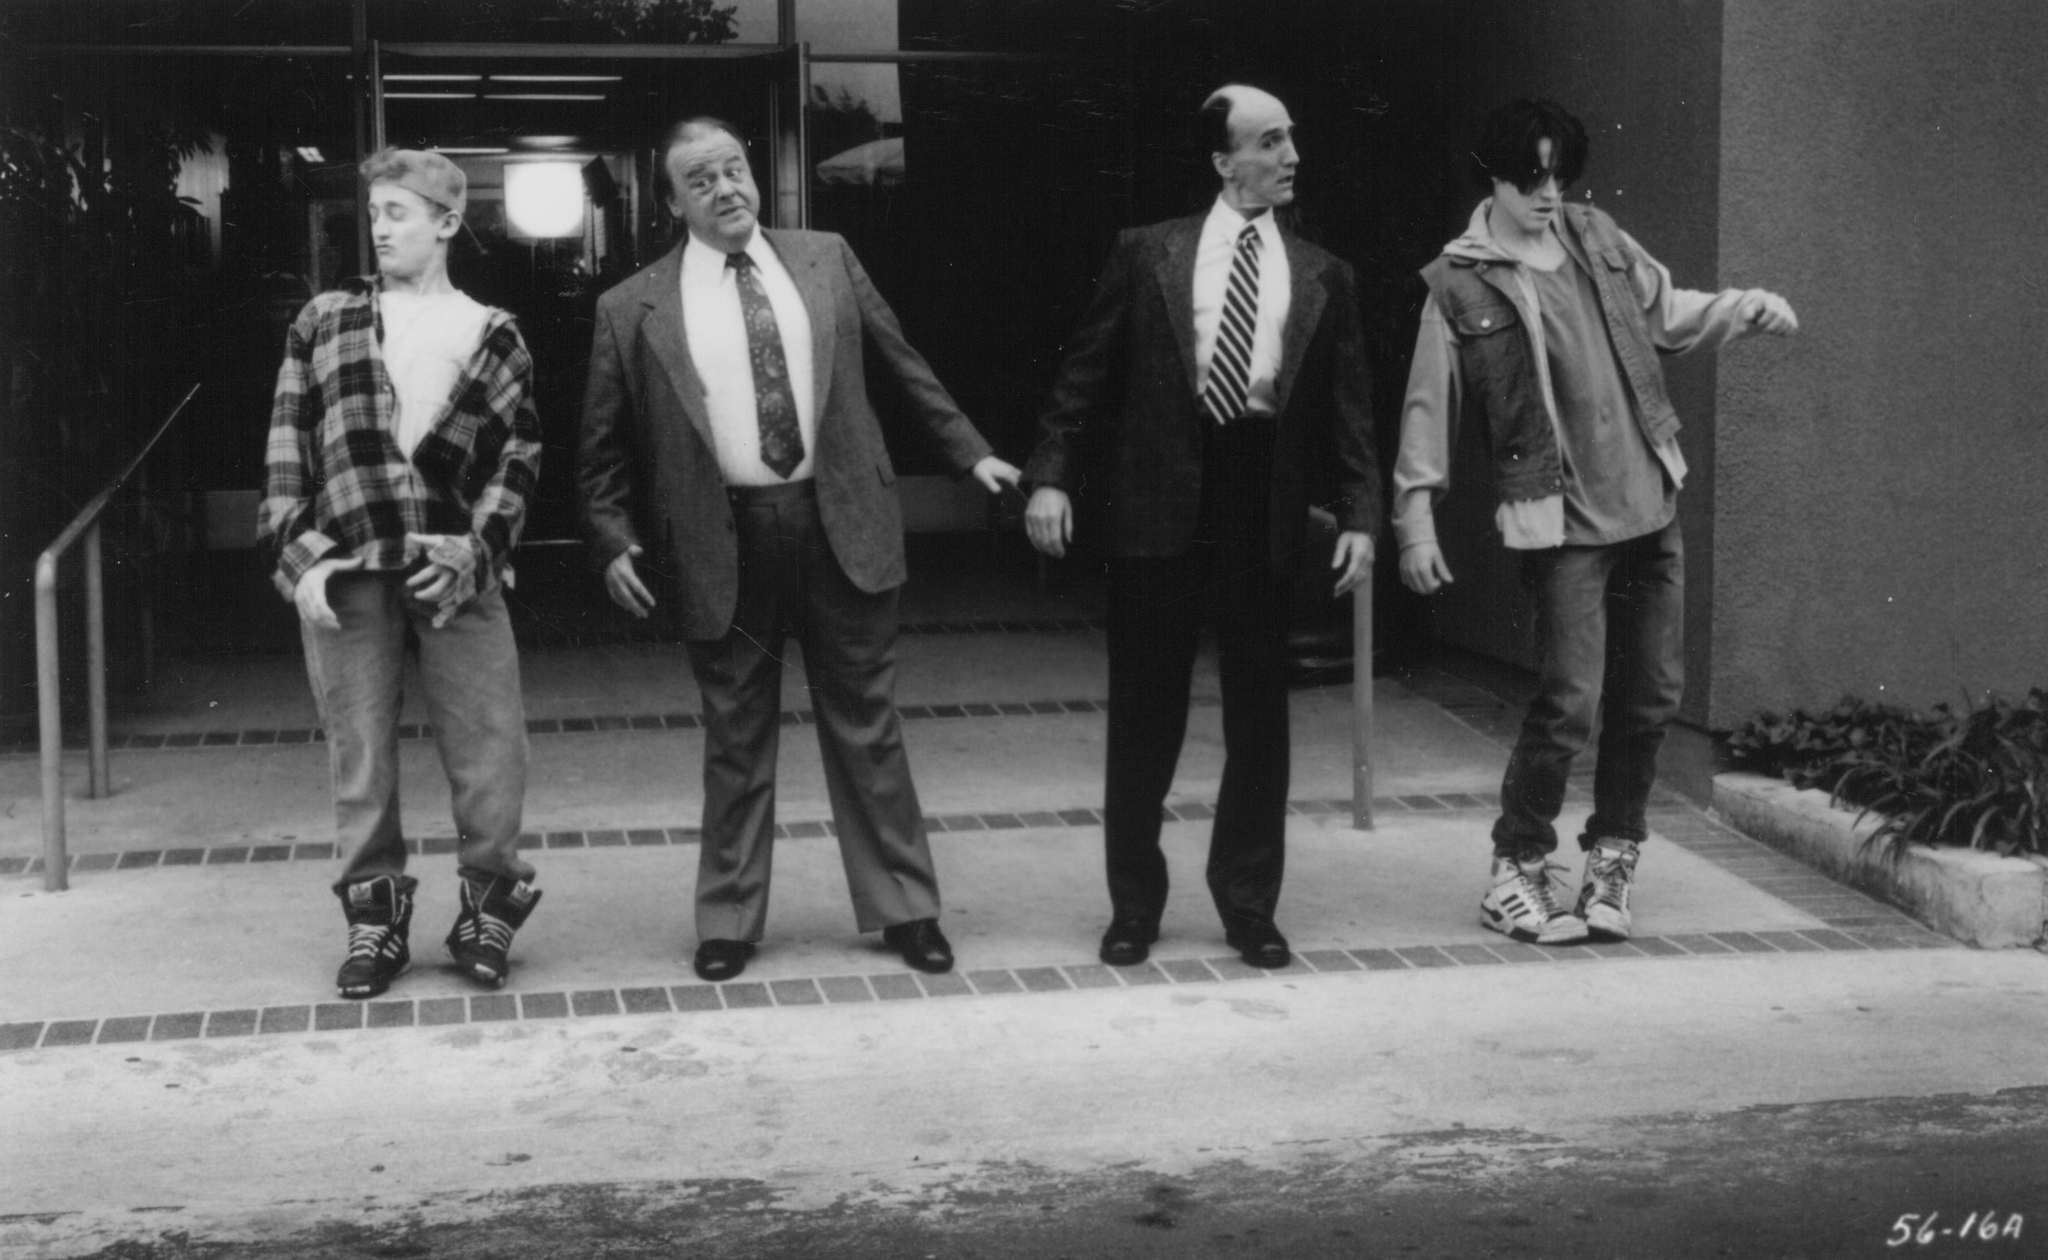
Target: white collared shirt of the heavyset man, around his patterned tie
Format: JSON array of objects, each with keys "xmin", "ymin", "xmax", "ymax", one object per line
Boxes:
[{"xmin": 680, "ymin": 229, "xmax": 817, "ymax": 486}]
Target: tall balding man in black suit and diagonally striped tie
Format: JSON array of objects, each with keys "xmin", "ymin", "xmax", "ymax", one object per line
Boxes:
[{"xmin": 1024, "ymin": 84, "xmax": 1378, "ymax": 967}]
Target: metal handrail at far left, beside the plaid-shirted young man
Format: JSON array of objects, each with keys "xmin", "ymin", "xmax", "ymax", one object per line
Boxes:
[{"xmin": 35, "ymin": 385, "xmax": 199, "ymax": 893}]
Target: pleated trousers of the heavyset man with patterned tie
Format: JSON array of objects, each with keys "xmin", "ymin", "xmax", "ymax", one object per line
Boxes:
[{"xmin": 688, "ymin": 481, "xmax": 938, "ymax": 940}]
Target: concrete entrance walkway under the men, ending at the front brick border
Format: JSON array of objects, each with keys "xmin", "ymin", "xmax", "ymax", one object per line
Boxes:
[{"xmin": 0, "ymin": 631, "xmax": 1933, "ymax": 1043}]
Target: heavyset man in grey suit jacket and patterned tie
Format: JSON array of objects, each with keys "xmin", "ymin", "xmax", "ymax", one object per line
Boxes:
[{"xmin": 578, "ymin": 119, "xmax": 1018, "ymax": 979}]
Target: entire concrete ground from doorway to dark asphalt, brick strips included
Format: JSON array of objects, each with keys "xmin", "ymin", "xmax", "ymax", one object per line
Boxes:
[{"xmin": 0, "ymin": 627, "xmax": 2048, "ymax": 1260}]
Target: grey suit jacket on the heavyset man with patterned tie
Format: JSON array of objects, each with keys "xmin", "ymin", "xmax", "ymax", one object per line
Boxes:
[{"xmin": 575, "ymin": 232, "xmax": 989, "ymax": 639}]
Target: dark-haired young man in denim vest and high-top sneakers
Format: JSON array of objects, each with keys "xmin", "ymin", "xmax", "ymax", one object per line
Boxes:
[{"xmin": 1395, "ymin": 100, "xmax": 1798, "ymax": 944}]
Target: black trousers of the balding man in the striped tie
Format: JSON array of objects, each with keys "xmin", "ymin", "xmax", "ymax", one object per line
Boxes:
[{"xmin": 1102, "ymin": 418, "xmax": 1288, "ymax": 930}]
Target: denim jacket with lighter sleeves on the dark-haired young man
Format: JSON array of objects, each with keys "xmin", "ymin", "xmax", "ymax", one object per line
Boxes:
[{"xmin": 1395, "ymin": 201, "xmax": 1743, "ymax": 549}]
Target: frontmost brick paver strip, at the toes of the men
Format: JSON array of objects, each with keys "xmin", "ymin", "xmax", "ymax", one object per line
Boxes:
[{"xmin": 0, "ymin": 924, "xmax": 1962, "ymax": 1051}]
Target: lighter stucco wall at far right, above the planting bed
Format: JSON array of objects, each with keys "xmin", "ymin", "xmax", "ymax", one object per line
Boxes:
[{"xmin": 1710, "ymin": 0, "xmax": 2048, "ymax": 725}]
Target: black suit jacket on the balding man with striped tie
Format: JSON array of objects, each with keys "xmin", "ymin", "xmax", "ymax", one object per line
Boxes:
[{"xmin": 1024, "ymin": 215, "xmax": 1380, "ymax": 563}]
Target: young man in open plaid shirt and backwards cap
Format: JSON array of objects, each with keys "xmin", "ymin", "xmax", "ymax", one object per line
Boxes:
[{"xmin": 260, "ymin": 150, "xmax": 541, "ymax": 998}]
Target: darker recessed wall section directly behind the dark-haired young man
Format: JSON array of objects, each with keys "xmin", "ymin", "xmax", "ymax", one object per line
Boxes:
[{"xmin": 1432, "ymin": 0, "xmax": 1720, "ymax": 717}]
